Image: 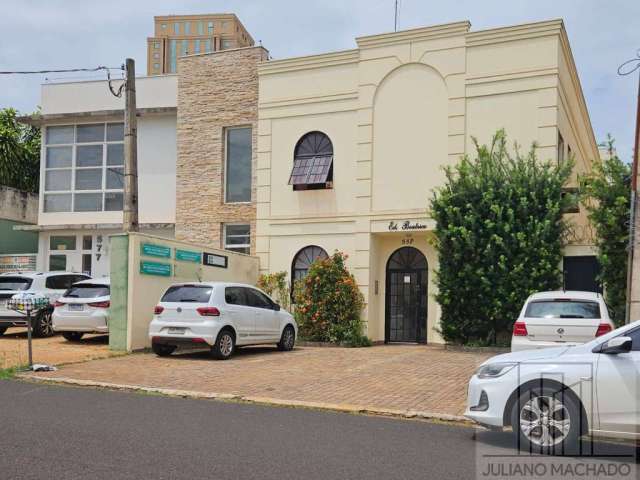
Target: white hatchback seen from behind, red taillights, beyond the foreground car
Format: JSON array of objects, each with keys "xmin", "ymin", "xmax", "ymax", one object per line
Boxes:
[{"xmin": 511, "ymin": 291, "xmax": 615, "ymax": 352}]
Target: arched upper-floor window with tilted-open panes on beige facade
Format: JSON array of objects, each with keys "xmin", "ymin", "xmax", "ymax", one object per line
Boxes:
[{"xmin": 289, "ymin": 132, "xmax": 333, "ymax": 190}]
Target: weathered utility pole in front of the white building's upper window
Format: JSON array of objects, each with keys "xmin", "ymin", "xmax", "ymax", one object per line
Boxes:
[{"xmin": 123, "ymin": 58, "xmax": 138, "ymax": 232}]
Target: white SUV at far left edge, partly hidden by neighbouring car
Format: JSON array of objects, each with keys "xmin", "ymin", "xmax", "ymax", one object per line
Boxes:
[{"xmin": 0, "ymin": 272, "xmax": 91, "ymax": 337}]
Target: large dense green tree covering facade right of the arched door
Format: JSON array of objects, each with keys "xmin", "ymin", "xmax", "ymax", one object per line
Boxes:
[{"xmin": 430, "ymin": 130, "xmax": 572, "ymax": 345}]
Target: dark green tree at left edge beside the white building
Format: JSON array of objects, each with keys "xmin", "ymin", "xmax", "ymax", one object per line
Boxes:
[{"xmin": 0, "ymin": 108, "xmax": 40, "ymax": 193}]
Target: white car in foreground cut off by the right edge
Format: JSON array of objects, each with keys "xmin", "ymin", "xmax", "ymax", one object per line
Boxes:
[{"xmin": 465, "ymin": 321, "xmax": 640, "ymax": 454}]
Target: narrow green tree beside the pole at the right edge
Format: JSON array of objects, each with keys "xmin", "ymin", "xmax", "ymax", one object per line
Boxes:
[{"xmin": 580, "ymin": 136, "xmax": 631, "ymax": 325}]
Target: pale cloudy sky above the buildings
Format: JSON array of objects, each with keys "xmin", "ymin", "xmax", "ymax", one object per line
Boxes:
[{"xmin": 0, "ymin": 0, "xmax": 640, "ymax": 161}]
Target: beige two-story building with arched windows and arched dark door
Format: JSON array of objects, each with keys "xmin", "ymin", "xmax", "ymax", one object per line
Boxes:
[{"xmin": 255, "ymin": 20, "xmax": 598, "ymax": 342}]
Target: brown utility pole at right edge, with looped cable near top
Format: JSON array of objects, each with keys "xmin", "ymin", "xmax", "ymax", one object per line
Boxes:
[{"xmin": 618, "ymin": 50, "xmax": 640, "ymax": 323}]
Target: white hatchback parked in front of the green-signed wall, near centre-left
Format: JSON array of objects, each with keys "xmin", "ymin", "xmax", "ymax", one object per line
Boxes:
[{"xmin": 149, "ymin": 282, "xmax": 298, "ymax": 360}]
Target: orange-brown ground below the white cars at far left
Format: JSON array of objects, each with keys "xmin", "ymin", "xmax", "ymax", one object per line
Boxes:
[{"xmin": 0, "ymin": 328, "xmax": 117, "ymax": 369}]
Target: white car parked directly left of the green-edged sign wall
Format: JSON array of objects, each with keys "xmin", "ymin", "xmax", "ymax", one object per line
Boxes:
[{"xmin": 52, "ymin": 277, "xmax": 111, "ymax": 342}]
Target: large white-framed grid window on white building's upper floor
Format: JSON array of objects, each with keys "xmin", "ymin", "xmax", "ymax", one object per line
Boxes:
[{"xmin": 41, "ymin": 123, "xmax": 124, "ymax": 212}]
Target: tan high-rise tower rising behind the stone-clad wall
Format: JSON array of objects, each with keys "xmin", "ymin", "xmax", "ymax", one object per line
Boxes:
[{"xmin": 147, "ymin": 13, "xmax": 254, "ymax": 75}]
